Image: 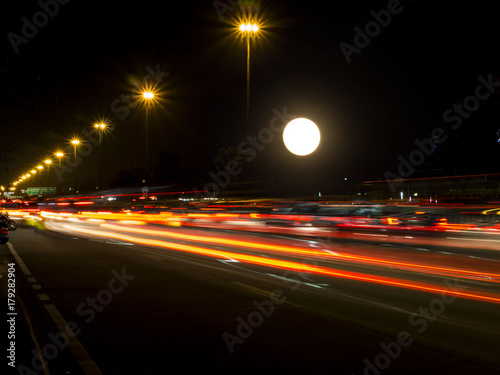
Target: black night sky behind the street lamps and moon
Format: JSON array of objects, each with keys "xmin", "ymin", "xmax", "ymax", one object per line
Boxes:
[{"xmin": 0, "ymin": 0, "xmax": 500, "ymax": 197}]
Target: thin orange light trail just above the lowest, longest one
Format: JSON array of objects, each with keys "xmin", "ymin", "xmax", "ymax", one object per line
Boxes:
[{"xmin": 100, "ymin": 224, "xmax": 500, "ymax": 281}]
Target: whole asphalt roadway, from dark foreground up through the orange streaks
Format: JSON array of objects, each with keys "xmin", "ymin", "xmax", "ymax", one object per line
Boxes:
[{"xmin": 0, "ymin": 223, "xmax": 500, "ymax": 375}]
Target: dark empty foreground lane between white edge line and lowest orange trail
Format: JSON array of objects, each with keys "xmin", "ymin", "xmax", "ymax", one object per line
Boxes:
[{"xmin": 0, "ymin": 223, "xmax": 500, "ymax": 374}]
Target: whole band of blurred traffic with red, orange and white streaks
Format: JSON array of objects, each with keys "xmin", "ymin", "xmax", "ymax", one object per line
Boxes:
[{"xmin": 3, "ymin": 195, "xmax": 500, "ymax": 303}]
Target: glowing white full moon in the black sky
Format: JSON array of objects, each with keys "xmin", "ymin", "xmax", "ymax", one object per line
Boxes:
[{"xmin": 283, "ymin": 118, "xmax": 321, "ymax": 156}]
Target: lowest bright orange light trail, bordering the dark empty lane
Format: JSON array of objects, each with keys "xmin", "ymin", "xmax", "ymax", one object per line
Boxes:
[{"xmin": 64, "ymin": 225, "xmax": 500, "ymax": 303}]
